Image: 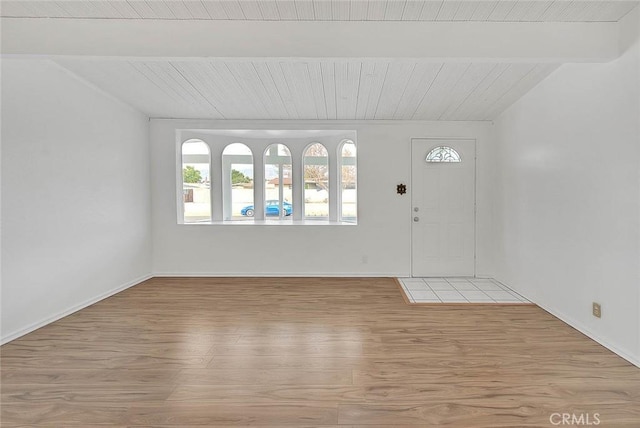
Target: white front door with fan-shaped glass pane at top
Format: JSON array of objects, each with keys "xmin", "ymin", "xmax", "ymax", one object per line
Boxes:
[{"xmin": 411, "ymin": 138, "xmax": 476, "ymax": 277}]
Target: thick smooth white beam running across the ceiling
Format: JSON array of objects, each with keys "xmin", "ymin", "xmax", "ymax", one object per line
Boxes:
[{"xmin": 0, "ymin": 18, "xmax": 620, "ymax": 63}]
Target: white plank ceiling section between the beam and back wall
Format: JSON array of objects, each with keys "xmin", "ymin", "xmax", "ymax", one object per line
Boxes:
[{"xmin": 56, "ymin": 59, "xmax": 558, "ymax": 120}]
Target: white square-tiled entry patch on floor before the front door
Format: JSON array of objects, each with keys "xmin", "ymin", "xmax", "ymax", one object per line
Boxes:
[{"xmin": 398, "ymin": 278, "xmax": 531, "ymax": 304}]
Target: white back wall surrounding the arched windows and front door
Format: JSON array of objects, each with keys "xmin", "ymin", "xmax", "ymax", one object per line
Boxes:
[{"xmin": 151, "ymin": 120, "xmax": 493, "ymax": 276}]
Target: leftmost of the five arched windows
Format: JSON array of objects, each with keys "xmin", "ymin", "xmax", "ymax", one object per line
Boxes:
[{"xmin": 182, "ymin": 140, "xmax": 211, "ymax": 223}]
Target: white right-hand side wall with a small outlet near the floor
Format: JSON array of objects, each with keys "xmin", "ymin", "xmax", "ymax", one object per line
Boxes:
[{"xmin": 494, "ymin": 11, "xmax": 640, "ymax": 364}]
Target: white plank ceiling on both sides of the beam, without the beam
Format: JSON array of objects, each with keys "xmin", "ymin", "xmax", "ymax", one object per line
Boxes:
[{"xmin": 5, "ymin": 0, "xmax": 638, "ymax": 120}]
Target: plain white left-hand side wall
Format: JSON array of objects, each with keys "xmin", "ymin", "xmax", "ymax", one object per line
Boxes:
[{"xmin": 1, "ymin": 58, "xmax": 151, "ymax": 342}]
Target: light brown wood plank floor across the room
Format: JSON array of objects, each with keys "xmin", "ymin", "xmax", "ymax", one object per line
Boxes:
[{"xmin": 0, "ymin": 278, "xmax": 640, "ymax": 428}]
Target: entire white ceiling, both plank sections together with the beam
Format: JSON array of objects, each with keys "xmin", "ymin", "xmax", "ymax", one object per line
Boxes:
[{"xmin": 0, "ymin": 0, "xmax": 638, "ymax": 120}]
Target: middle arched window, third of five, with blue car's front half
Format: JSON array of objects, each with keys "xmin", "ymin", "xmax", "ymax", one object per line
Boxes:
[{"xmin": 264, "ymin": 144, "xmax": 293, "ymax": 220}]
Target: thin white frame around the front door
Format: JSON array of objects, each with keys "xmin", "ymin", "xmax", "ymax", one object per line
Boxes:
[{"xmin": 408, "ymin": 137, "xmax": 478, "ymax": 278}]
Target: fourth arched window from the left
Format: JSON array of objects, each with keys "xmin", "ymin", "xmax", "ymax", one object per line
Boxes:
[{"xmin": 303, "ymin": 143, "xmax": 329, "ymax": 219}]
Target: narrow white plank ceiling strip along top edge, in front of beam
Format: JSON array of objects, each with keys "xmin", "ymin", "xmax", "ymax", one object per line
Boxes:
[{"xmin": 0, "ymin": 0, "xmax": 637, "ymax": 22}]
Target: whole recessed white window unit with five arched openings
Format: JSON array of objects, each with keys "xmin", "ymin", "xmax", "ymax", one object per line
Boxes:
[{"xmin": 178, "ymin": 129, "xmax": 358, "ymax": 227}]
